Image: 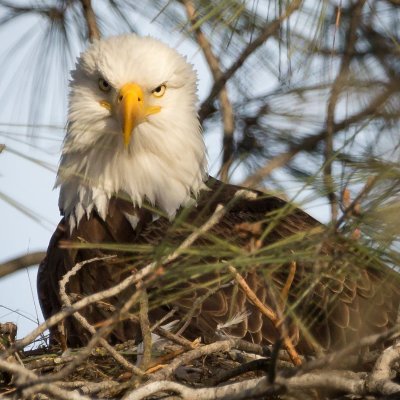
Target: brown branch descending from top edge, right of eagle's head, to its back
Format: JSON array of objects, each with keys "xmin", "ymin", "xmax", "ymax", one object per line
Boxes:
[{"xmin": 182, "ymin": 0, "xmax": 235, "ymax": 182}]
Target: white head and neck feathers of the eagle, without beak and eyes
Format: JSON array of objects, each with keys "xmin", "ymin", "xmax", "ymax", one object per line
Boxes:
[{"xmin": 56, "ymin": 35, "xmax": 206, "ymax": 229}]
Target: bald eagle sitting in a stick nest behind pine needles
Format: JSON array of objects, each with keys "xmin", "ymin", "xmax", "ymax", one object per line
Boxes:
[{"xmin": 38, "ymin": 35, "xmax": 399, "ymax": 354}]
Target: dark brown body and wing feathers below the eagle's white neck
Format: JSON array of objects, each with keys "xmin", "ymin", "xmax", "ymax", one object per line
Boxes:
[{"xmin": 38, "ymin": 179, "xmax": 400, "ymax": 353}]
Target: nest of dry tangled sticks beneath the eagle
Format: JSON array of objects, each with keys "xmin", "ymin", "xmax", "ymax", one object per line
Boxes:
[{"xmin": 0, "ymin": 323, "xmax": 400, "ymax": 400}]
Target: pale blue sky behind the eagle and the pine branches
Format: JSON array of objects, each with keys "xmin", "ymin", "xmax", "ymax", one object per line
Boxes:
[{"xmin": 0, "ymin": 1, "xmax": 328, "ymax": 338}]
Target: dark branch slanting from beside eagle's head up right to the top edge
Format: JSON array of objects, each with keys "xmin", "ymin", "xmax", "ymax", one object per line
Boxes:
[{"xmin": 199, "ymin": 0, "xmax": 302, "ymax": 121}]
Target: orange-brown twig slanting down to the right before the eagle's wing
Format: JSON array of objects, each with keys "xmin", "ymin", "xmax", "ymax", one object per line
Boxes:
[{"xmin": 228, "ymin": 265, "xmax": 301, "ymax": 365}]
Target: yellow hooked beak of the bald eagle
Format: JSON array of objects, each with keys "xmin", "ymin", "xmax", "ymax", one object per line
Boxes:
[{"xmin": 117, "ymin": 83, "xmax": 161, "ymax": 148}]
